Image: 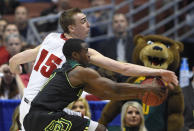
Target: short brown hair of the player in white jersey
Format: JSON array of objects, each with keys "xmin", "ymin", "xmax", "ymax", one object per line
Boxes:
[{"xmin": 59, "ymin": 8, "xmax": 82, "ymax": 33}]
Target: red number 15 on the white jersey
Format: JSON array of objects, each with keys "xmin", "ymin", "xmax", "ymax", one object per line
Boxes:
[{"xmin": 34, "ymin": 49, "xmax": 62, "ymax": 78}]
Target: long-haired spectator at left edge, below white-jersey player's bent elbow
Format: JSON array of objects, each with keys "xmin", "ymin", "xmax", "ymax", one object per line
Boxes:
[{"xmin": 0, "ymin": 64, "xmax": 23, "ymax": 99}]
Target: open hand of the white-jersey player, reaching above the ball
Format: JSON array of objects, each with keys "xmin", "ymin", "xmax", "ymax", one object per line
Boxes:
[{"xmin": 160, "ymin": 69, "xmax": 178, "ymax": 89}]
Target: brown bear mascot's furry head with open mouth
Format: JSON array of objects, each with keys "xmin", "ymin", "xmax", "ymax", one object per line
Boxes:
[{"xmin": 133, "ymin": 35, "xmax": 183, "ymax": 71}]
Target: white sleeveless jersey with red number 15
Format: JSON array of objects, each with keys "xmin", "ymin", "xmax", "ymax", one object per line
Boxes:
[{"xmin": 24, "ymin": 33, "xmax": 67, "ymax": 101}]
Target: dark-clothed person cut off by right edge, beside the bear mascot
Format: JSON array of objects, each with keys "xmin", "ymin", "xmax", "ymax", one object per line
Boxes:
[{"xmin": 182, "ymin": 67, "xmax": 194, "ymax": 131}]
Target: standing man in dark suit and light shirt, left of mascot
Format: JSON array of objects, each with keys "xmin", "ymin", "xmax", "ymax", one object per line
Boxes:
[{"xmin": 100, "ymin": 13, "xmax": 134, "ymax": 63}]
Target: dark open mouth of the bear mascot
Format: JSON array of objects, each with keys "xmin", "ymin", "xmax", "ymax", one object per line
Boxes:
[{"xmin": 148, "ymin": 56, "xmax": 166, "ymax": 66}]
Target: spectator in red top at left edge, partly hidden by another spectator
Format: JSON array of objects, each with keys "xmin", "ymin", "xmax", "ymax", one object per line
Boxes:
[{"xmin": 0, "ymin": 24, "xmax": 19, "ymax": 65}]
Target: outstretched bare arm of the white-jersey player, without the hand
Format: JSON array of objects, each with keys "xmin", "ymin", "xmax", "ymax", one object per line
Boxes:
[{"xmin": 89, "ymin": 49, "xmax": 161, "ymax": 76}]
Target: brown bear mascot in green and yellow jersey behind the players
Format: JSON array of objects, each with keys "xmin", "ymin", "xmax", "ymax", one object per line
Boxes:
[{"xmin": 99, "ymin": 35, "xmax": 184, "ymax": 131}]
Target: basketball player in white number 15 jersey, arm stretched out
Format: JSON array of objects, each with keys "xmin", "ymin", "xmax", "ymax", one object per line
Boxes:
[{"xmin": 9, "ymin": 8, "xmax": 178, "ymax": 130}]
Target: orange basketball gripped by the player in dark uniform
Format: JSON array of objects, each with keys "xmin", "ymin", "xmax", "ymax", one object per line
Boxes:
[{"xmin": 141, "ymin": 77, "xmax": 168, "ymax": 106}]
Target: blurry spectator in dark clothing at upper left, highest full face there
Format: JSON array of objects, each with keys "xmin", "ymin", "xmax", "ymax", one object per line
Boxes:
[{"xmin": 14, "ymin": 6, "xmax": 28, "ymax": 40}]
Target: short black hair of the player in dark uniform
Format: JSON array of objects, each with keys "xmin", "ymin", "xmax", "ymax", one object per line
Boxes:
[{"xmin": 63, "ymin": 39, "xmax": 85, "ymax": 59}]
